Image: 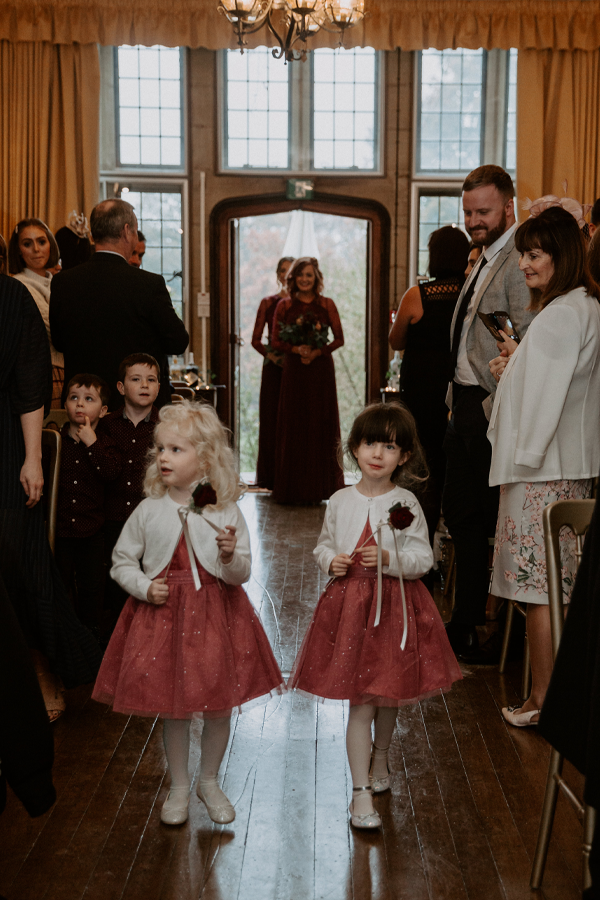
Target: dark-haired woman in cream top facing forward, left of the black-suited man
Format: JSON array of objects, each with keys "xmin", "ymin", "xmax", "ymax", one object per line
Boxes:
[{"xmin": 8, "ymin": 219, "xmax": 65, "ymax": 409}]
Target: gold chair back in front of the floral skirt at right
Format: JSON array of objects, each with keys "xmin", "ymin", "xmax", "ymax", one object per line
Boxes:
[{"xmin": 542, "ymin": 500, "xmax": 596, "ymax": 658}]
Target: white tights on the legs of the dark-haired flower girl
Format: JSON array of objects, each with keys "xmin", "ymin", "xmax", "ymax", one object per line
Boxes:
[{"xmin": 346, "ymin": 704, "xmax": 398, "ymax": 815}]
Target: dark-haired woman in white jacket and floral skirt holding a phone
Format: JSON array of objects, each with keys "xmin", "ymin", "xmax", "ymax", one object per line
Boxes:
[{"xmin": 488, "ymin": 206, "xmax": 600, "ymax": 726}]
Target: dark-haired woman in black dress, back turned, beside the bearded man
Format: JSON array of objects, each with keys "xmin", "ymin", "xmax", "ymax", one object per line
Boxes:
[{"xmin": 389, "ymin": 225, "xmax": 469, "ymax": 539}]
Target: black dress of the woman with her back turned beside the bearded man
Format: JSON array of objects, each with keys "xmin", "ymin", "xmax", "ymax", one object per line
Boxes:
[{"xmin": 400, "ymin": 278, "xmax": 464, "ymax": 537}]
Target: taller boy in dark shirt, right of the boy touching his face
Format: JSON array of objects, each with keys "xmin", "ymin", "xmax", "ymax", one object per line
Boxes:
[{"xmin": 102, "ymin": 353, "xmax": 160, "ymax": 615}]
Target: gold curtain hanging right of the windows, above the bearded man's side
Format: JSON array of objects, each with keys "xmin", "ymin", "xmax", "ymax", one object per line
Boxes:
[{"xmin": 517, "ymin": 50, "xmax": 600, "ymax": 218}]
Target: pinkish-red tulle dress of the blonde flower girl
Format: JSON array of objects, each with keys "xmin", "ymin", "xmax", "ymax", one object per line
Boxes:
[{"xmin": 92, "ymin": 536, "xmax": 284, "ymax": 719}]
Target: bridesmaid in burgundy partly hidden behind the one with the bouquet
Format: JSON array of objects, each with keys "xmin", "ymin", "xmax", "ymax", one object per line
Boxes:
[{"xmin": 252, "ymin": 256, "xmax": 294, "ymax": 490}]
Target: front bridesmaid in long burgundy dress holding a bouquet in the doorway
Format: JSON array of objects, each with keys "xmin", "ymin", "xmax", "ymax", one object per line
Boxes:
[{"xmin": 272, "ymin": 256, "xmax": 344, "ymax": 504}]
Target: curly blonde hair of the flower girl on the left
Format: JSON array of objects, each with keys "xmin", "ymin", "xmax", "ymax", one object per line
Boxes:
[{"xmin": 144, "ymin": 400, "xmax": 245, "ymax": 509}]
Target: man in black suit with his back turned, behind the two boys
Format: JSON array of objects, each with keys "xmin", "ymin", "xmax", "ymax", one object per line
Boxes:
[{"xmin": 50, "ymin": 200, "xmax": 189, "ymax": 410}]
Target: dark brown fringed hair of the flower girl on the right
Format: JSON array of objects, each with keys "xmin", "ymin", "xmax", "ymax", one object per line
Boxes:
[{"xmin": 341, "ymin": 402, "xmax": 429, "ymax": 490}]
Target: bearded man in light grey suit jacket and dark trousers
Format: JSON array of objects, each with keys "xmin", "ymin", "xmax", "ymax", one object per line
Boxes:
[{"xmin": 442, "ymin": 165, "xmax": 534, "ymax": 663}]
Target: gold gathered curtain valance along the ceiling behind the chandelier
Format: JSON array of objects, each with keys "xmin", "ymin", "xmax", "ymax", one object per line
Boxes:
[{"xmin": 0, "ymin": 0, "xmax": 600, "ymax": 50}]
